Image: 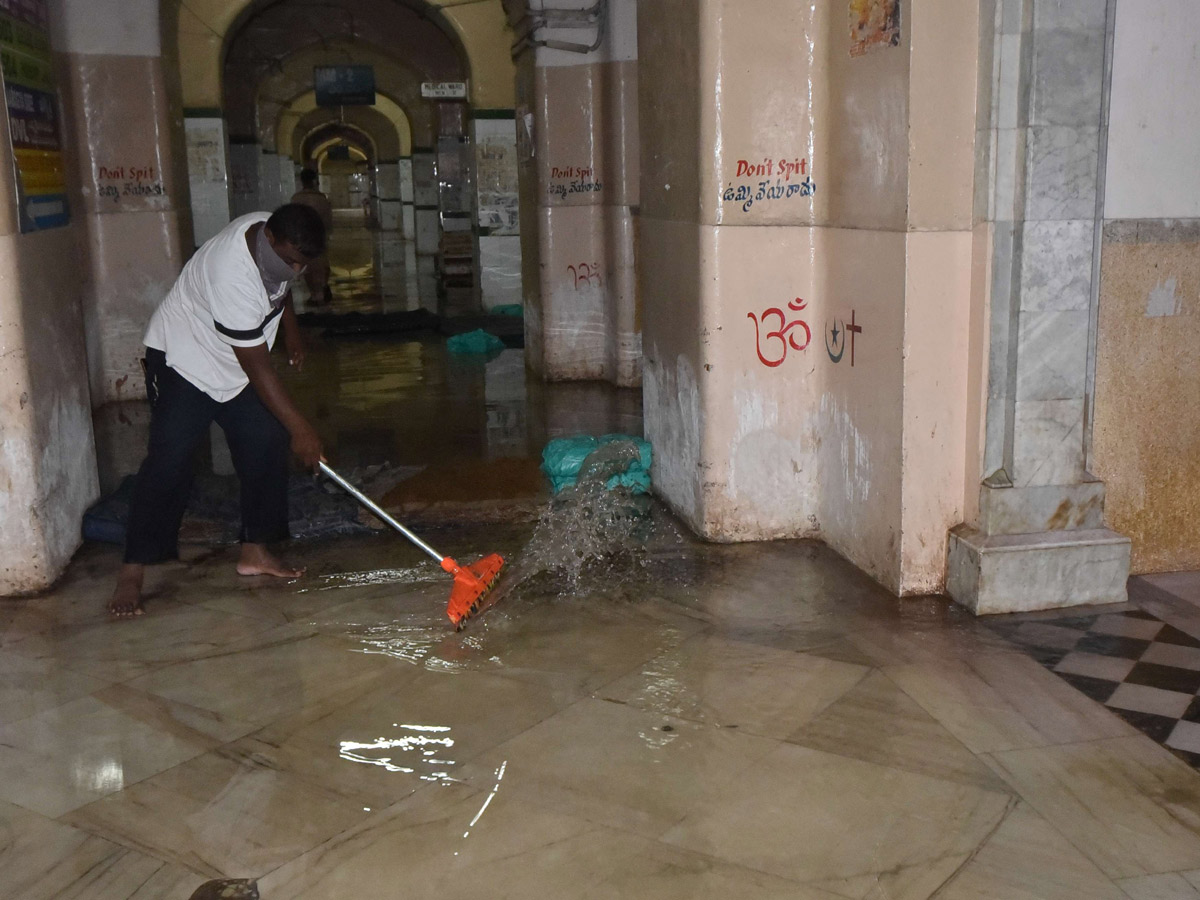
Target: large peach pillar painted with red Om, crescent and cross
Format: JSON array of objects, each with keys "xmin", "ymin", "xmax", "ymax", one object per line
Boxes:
[{"xmin": 638, "ymin": 0, "xmax": 978, "ymax": 594}]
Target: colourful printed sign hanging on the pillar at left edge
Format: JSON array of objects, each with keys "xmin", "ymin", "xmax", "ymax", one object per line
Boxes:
[{"xmin": 0, "ymin": 0, "xmax": 71, "ymax": 232}]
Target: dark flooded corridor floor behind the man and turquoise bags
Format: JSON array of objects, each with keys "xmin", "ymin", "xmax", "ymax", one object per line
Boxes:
[{"xmin": 95, "ymin": 220, "xmax": 642, "ymax": 496}]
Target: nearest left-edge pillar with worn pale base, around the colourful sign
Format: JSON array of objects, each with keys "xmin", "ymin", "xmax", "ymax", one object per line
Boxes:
[{"xmin": 0, "ymin": 4, "xmax": 114, "ymax": 595}]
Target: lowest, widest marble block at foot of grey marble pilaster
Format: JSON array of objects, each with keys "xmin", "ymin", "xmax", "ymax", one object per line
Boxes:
[{"xmin": 946, "ymin": 526, "xmax": 1130, "ymax": 616}]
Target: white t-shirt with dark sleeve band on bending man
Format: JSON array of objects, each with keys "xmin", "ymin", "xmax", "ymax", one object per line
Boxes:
[{"xmin": 143, "ymin": 212, "xmax": 288, "ymax": 403}]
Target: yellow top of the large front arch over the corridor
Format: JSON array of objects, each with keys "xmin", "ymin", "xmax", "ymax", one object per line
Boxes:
[{"xmin": 172, "ymin": 0, "xmax": 515, "ymax": 108}]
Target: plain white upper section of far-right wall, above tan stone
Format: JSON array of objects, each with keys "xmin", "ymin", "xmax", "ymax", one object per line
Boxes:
[{"xmin": 1104, "ymin": 0, "xmax": 1200, "ymax": 218}]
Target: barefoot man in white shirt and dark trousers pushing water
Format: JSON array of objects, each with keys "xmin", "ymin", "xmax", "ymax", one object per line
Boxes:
[{"xmin": 108, "ymin": 204, "xmax": 325, "ymax": 618}]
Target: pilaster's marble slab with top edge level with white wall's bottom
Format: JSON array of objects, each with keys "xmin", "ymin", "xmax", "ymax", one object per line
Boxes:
[{"xmin": 1021, "ymin": 218, "xmax": 1096, "ymax": 312}]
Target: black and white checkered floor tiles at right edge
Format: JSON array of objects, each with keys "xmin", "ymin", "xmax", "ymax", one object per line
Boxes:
[{"xmin": 989, "ymin": 610, "xmax": 1200, "ymax": 768}]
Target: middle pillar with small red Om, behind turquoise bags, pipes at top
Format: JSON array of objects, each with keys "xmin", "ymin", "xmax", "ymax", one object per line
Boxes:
[{"xmin": 516, "ymin": 0, "xmax": 642, "ymax": 385}]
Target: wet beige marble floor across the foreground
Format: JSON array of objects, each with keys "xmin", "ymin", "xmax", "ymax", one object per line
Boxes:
[{"xmin": 11, "ymin": 511, "xmax": 1200, "ymax": 900}]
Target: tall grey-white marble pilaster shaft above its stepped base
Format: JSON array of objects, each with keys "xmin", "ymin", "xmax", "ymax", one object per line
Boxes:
[{"xmin": 976, "ymin": 0, "xmax": 1109, "ymax": 504}]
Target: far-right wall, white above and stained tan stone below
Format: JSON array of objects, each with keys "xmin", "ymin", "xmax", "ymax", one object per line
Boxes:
[{"xmin": 1091, "ymin": 0, "xmax": 1200, "ymax": 572}]
